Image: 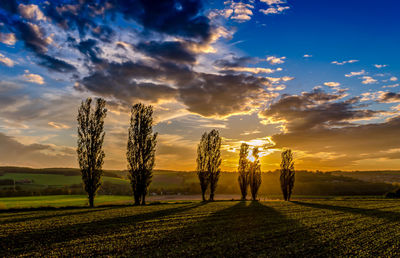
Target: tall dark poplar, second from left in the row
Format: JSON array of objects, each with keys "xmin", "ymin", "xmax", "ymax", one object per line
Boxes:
[{"xmin": 126, "ymin": 103, "xmax": 157, "ymax": 205}]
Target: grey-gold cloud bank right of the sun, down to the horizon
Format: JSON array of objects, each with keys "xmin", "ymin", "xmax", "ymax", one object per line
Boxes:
[{"xmin": 259, "ymin": 89, "xmax": 400, "ymax": 169}]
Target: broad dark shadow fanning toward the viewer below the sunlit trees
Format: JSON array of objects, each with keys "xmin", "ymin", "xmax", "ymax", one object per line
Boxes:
[{"xmin": 123, "ymin": 202, "xmax": 331, "ymax": 257}]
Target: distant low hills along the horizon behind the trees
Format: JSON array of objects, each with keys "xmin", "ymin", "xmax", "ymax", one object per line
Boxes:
[{"xmin": 0, "ymin": 167, "xmax": 400, "ymax": 196}]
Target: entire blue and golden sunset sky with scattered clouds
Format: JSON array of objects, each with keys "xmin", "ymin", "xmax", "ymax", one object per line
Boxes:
[{"xmin": 0, "ymin": 0, "xmax": 400, "ymax": 171}]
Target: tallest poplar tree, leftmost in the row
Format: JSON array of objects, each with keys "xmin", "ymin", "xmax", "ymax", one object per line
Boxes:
[{"xmin": 76, "ymin": 98, "xmax": 107, "ymax": 207}]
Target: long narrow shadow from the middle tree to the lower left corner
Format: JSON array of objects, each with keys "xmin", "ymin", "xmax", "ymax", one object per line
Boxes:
[{"xmin": 0, "ymin": 203, "xmax": 204, "ymax": 257}]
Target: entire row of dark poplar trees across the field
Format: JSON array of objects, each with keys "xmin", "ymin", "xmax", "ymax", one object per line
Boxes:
[{"xmin": 77, "ymin": 98, "xmax": 294, "ymax": 207}]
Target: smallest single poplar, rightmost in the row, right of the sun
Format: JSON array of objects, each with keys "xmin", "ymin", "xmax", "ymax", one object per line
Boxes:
[{"xmin": 280, "ymin": 149, "xmax": 295, "ymax": 201}]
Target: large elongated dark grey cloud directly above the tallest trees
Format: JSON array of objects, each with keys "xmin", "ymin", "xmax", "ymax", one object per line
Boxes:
[{"xmin": 77, "ymin": 59, "xmax": 276, "ymax": 117}]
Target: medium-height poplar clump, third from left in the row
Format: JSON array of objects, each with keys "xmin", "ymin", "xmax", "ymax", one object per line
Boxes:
[{"xmin": 197, "ymin": 129, "xmax": 222, "ymax": 201}]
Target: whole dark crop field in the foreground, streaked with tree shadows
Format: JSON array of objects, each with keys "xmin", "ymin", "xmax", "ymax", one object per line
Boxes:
[{"xmin": 0, "ymin": 200, "xmax": 400, "ymax": 257}]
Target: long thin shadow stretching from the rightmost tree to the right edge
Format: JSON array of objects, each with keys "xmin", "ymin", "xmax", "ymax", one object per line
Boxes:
[{"xmin": 293, "ymin": 201, "xmax": 400, "ymax": 222}]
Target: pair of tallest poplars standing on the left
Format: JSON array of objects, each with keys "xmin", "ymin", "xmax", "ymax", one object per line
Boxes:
[{"xmin": 77, "ymin": 98, "xmax": 157, "ymax": 207}]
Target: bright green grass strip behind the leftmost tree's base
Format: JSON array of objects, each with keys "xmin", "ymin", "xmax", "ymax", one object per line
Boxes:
[{"xmin": 0, "ymin": 195, "xmax": 132, "ymax": 210}]
